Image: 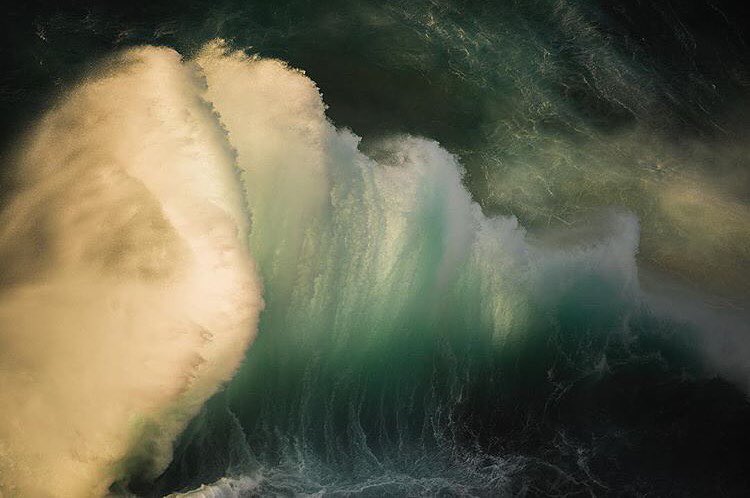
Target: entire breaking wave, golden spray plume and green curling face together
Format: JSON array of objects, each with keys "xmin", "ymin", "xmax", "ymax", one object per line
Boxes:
[{"xmin": 0, "ymin": 41, "xmax": 750, "ymax": 497}]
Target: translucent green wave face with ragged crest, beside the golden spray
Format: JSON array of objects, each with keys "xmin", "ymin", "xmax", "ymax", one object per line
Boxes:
[{"xmin": 135, "ymin": 42, "xmax": 746, "ymax": 496}]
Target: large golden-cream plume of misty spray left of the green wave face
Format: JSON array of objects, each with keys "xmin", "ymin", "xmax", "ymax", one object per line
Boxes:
[{"xmin": 0, "ymin": 48, "xmax": 262, "ymax": 497}]
